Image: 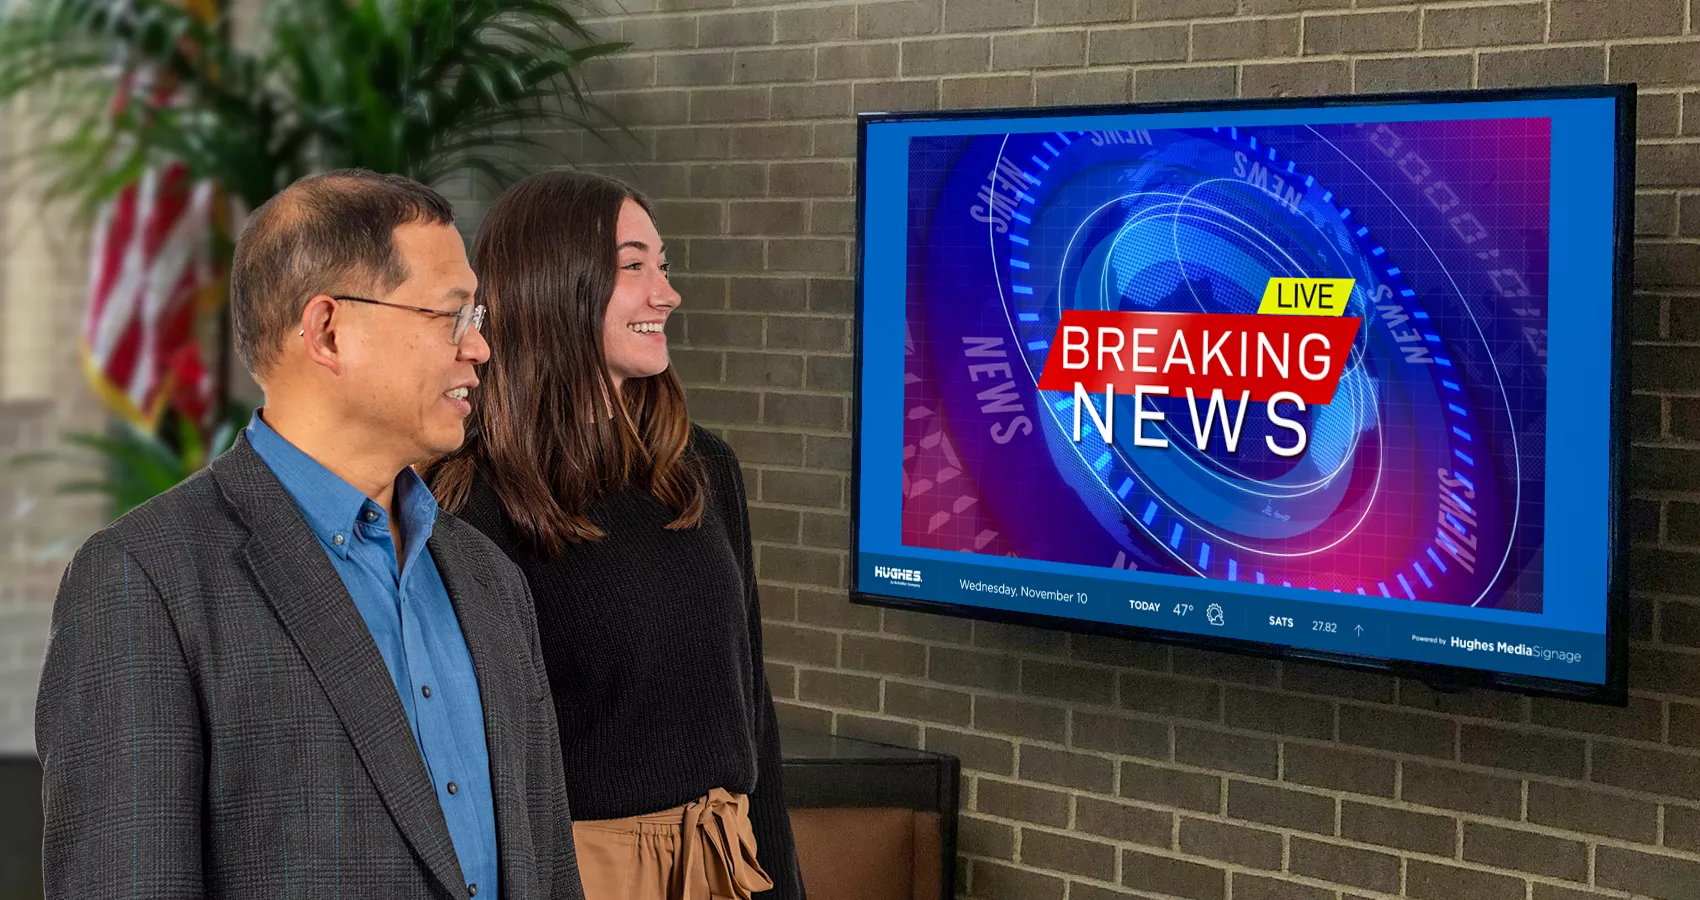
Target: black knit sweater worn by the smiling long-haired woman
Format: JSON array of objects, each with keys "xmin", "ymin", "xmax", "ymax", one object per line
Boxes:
[{"xmin": 459, "ymin": 425, "xmax": 802, "ymax": 900}]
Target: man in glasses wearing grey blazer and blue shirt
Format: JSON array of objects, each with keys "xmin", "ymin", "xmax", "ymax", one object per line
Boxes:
[{"xmin": 36, "ymin": 170, "xmax": 583, "ymax": 900}]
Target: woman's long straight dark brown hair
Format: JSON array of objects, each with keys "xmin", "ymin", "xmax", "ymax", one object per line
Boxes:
[{"xmin": 427, "ymin": 170, "xmax": 704, "ymax": 556}]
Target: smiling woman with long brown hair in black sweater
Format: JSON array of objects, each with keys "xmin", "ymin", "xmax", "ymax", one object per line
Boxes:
[{"xmin": 430, "ymin": 172, "xmax": 802, "ymax": 900}]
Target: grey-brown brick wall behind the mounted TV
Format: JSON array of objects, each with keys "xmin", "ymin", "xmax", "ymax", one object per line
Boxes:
[{"xmin": 567, "ymin": 0, "xmax": 1700, "ymax": 900}]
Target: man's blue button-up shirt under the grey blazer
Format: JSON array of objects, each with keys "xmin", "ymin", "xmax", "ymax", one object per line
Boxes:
[{"xmin": 248, "ymin": 412, "xmax": 500, "ymax": 900}]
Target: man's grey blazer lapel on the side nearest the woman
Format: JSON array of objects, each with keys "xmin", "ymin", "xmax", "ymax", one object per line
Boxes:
[{"xmin": 425, "ymin": 514, "xmax": 534, "ymax": 885}]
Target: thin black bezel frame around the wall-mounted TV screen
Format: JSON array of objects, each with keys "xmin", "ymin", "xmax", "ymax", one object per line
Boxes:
[{"xmin": 848, "ymin": 83, "xmax": 1635, "ymax": 706}]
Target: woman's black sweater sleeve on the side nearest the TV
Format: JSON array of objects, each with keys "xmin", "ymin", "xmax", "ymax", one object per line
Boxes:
[{"xmin": 714, "ymin": 435, "xmax": 804, "ymax": 900}]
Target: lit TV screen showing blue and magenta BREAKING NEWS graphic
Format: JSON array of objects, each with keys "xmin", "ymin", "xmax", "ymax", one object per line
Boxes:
[{"xmin": 860, "ymin": 93, "xmax": 1612, "ymax": 694}]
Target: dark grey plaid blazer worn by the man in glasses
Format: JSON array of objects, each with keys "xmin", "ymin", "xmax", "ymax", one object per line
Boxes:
[{"xmin": 36, "ymin": 437, "xmax": 583, "ymax": 900}]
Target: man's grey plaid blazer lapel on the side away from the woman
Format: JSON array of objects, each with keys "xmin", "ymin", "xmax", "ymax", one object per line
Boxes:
[{"xmin": 211, "ymin": 436, "xmax": 466, "ymax": 897}]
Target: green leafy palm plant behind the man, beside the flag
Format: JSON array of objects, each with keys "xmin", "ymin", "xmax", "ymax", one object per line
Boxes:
[{"xmin": 0, "ymin": 0, "xmax": 626, "ymax": 512}]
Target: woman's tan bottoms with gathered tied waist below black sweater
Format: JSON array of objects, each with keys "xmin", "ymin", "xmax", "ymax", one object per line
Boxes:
[{"xmin": 573, "ymin": 788, "xmax": 774, "ymax": 900}]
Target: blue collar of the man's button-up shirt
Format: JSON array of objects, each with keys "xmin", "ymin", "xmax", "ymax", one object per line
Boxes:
[{"xmin": 248, "ymin": 410, "xmax": 437, "ymax": 568}]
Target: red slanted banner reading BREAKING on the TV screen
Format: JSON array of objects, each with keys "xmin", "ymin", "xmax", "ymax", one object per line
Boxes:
[{"xmin": 1039, "ymin": 310, "xmax": 1363, "ymax": 405}]
